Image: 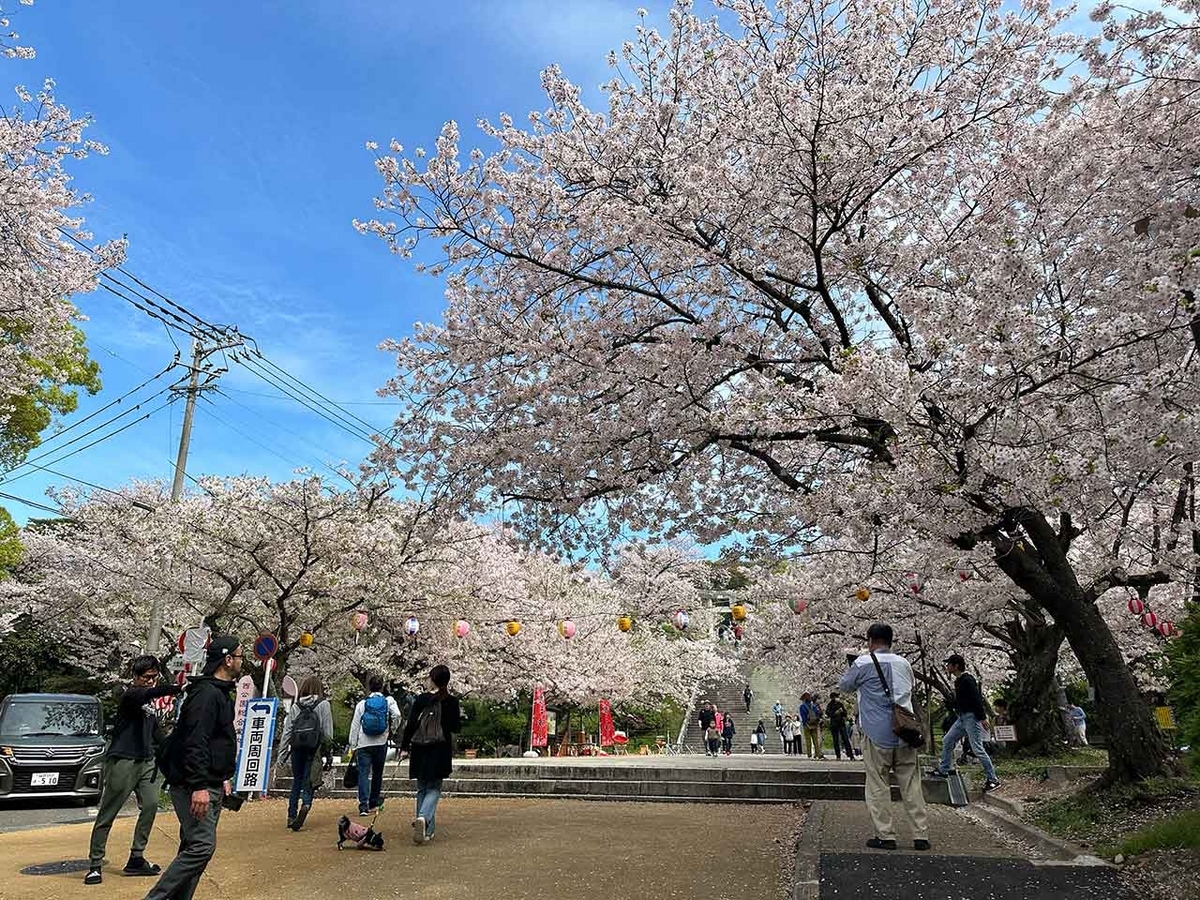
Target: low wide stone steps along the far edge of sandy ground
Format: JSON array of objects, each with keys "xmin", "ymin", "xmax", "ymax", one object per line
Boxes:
[{"xmin": 274, "ymin": 758, "xmax": 902, "ymax": 804}]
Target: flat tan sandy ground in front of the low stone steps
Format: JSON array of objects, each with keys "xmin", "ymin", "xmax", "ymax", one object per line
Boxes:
[{"xmin": 0, "ymin": 798, "xmax": 802, "ymax": 900}]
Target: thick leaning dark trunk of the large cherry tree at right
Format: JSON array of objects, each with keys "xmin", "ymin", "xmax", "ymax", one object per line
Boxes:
[{"xmin": 990, "ymin": 509, "xmax": 1171, "ymax": 782}]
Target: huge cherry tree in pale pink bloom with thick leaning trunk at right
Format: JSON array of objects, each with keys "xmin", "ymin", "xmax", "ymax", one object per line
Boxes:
[{"xmin": 358, "ymin": 0, "xmax": 1200, "ymax": 779}]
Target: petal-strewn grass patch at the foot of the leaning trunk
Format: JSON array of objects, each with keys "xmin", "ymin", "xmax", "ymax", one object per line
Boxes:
[{"xmin": 1032, "ymin": 778, "xmax": 1200, "ymax": 853}]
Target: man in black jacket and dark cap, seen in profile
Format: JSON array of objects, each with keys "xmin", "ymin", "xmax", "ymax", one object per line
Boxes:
[{"xmin": 145, "ymin": 637, "xmax": 241, "ymax": 900}]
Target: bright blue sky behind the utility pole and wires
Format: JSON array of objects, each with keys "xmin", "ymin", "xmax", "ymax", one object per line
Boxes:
[{"xmin": 0, "ymin": 0, "xmax": 666, "ymax": 521}]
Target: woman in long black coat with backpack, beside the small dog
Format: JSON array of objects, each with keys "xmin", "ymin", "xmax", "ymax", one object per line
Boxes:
[{"xmin": 400, "ymin": 666, "xmax": 462, "ymax": 844}]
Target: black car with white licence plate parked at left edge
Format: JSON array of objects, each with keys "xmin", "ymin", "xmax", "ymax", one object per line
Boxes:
[{"xmin": 0, "ymin": 694, "xmax": 104, "ymax": 803}]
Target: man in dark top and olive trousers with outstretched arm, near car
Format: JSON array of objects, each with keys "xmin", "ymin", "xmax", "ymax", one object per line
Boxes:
[{"xmin": 83, "ymin": 656, "xmax": 182, "ymax": 884}]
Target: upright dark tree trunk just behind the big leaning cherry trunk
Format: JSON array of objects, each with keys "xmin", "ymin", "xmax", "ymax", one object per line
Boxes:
[{"xmin": 1008, "ymin": 622, "xmax": 1063, "ymax": 754}]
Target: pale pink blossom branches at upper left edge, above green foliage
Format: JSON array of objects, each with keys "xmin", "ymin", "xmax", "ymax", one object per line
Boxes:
[{"xmin": 0, "ymin": 8, "xmax": 125, "ymax": 446}]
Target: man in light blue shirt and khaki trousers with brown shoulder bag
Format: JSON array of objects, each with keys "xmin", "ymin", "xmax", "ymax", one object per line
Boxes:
[{"xmin": 838, "ymin": 622, "xmax": 930, "ymax": 850}]
